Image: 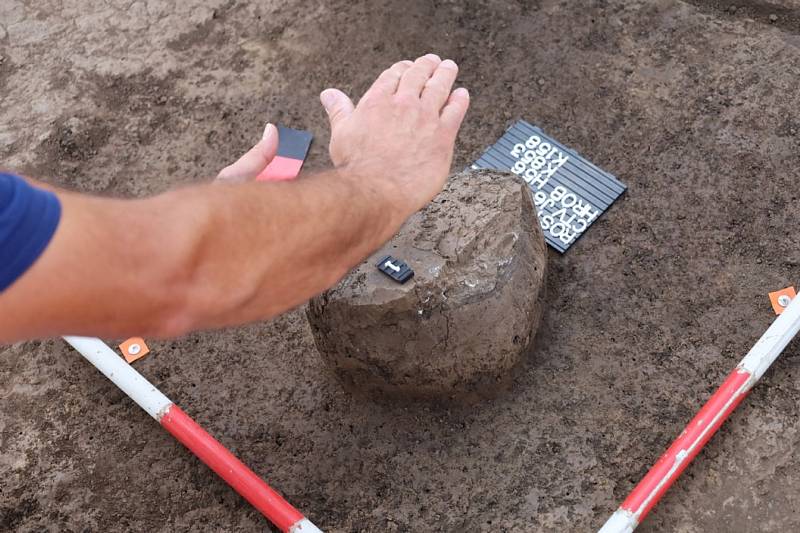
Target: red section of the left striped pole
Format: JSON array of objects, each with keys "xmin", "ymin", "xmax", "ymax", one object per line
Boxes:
[{"xmin": 161, "ymin": 404, "xmax": 303, "ymax": 532}]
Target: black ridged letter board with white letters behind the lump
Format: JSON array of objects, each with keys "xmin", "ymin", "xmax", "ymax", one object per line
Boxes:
[{"xmin": 472, "ymin": 120, "xmax": 627, "ymax": 253}]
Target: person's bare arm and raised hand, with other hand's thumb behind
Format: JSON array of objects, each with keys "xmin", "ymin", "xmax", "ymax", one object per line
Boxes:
[{"xmin": 0, "ymin": 56, "xmax": 469, "ymax": 342}]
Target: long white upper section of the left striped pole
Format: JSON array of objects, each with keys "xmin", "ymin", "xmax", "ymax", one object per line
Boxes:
[{"xmin": 64, "ymin": 337, "xmax": 172, "ymax": 422}]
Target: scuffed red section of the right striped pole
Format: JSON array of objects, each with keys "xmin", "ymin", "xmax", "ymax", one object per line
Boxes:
[{"xmin": 621, "ymin": 369, "xmax": 751, "ymax": 522}]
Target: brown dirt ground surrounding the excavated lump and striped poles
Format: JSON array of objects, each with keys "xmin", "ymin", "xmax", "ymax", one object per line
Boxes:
[{"xmin": 0, "ymin": 0, "xmax": 800, "ymax": 533}]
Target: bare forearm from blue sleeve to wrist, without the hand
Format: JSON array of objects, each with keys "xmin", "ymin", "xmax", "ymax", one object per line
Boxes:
[{"xmin": 0, "ymin": 170, "xmax": 400, "ymax": 342}]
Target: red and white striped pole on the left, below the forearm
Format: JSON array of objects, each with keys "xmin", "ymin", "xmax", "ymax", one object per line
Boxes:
[{"xmin": 64, "ymin": 337, "xmax": 322, "ymax": 533}]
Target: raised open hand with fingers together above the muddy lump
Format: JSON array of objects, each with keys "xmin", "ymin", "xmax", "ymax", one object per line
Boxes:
[{"xmin": 320, "ymin": 54, "xmax": 469, "ymax": 218}]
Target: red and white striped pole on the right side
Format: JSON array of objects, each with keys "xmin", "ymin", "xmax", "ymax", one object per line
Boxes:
[{"xmin": 599, "ymin": 298, "xmax": 800, "ymax": 533}]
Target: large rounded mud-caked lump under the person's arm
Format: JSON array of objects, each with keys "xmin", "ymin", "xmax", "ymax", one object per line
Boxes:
[{"xmin": 308, "ymin": 170, "xmax": 547, "ymax": 399}]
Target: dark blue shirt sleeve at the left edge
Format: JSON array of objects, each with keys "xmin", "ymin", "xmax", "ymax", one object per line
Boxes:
[{"xmin": 0, "ymin": 172, "xmax": 61, "ymax": 292}]
